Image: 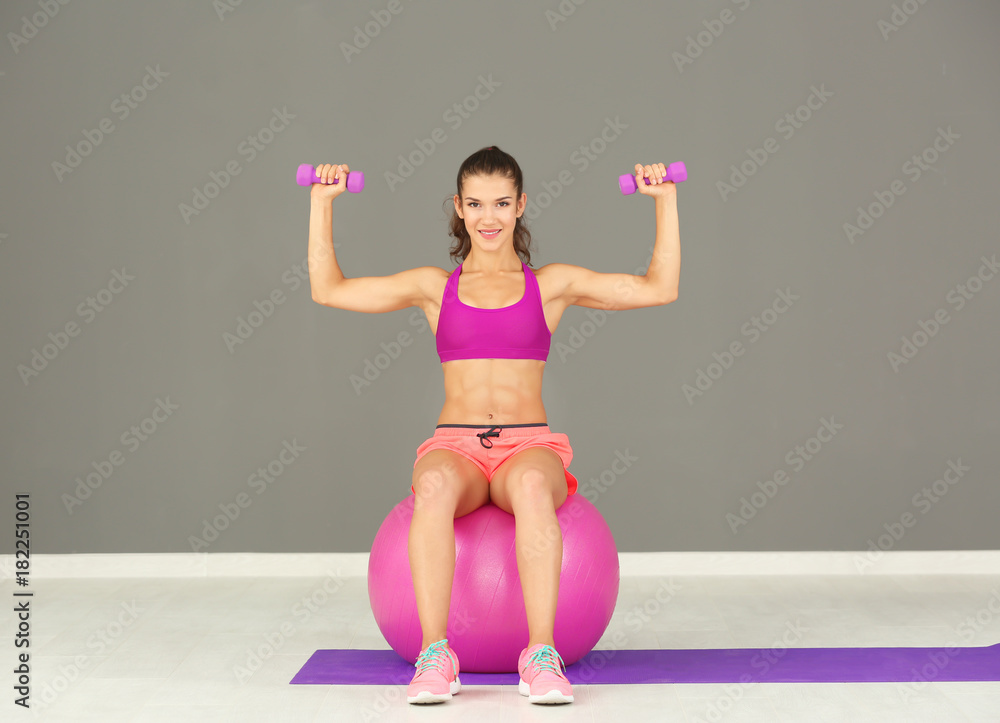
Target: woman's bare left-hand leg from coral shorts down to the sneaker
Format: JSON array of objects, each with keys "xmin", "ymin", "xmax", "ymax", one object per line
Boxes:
[{"xmin": 409, "ymin": 449, "xmax": 490, "ymax": 650}]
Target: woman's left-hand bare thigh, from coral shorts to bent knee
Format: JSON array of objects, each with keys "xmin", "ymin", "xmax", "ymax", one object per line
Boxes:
[{"xmin": 412, "ymin": 449, "xmax": 490, "ymax": 517}]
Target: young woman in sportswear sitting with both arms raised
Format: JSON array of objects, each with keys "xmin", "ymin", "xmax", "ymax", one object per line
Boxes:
[{"xmin": 309, "ymin": 146, "xmax": 680, "ymax": 703}]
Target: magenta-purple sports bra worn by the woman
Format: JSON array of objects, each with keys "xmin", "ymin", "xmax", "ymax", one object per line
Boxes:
[{"xmin": 437, "ymin": 261, "xmax": 552, "ymax": 363}]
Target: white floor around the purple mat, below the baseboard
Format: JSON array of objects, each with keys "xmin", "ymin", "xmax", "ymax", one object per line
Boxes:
[{"xmin": 0, "ymin": 575, "xmax": 1000, "ymax": 723}]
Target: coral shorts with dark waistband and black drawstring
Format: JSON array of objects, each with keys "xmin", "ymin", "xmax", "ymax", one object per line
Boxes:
[{"xmin": 410, "ymin": 424, "xmax": 579, "ymax": 495}]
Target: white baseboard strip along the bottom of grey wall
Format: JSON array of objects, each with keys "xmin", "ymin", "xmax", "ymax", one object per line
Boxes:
[{"xmin": 0, "ymin": 550, "xmax": 1000, "ymax": 581}]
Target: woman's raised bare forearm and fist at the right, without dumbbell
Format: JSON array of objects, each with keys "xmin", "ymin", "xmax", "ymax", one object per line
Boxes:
[{"xmin": 635, "ymin": 163, "xmax": 681, "ymax": 299}]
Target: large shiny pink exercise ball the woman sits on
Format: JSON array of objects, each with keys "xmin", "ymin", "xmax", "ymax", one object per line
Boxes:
[{"xmin": 368, "ymin": 494, "xmax": 619, "ymax": 673}]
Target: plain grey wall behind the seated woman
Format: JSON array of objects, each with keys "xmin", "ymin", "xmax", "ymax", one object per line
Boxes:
[{"xmin": 0, "ymin": 0, "xmax": 1000, "ymax": 553}]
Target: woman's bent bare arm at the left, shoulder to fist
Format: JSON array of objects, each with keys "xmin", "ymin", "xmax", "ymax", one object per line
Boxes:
[{"xmin": 308, "ymin": 164, "xmax": 436, "ymax": 314}]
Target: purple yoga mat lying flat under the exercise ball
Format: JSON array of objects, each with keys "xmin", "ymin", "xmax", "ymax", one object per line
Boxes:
[{"xmin": 291, "ymin": 644, "xmax": 1000, "ymax": 685}]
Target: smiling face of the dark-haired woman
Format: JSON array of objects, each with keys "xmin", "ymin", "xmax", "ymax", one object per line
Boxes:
[{"xmin": 455, "ymin": 176, "xmax": 528, "ymax": 249}]
